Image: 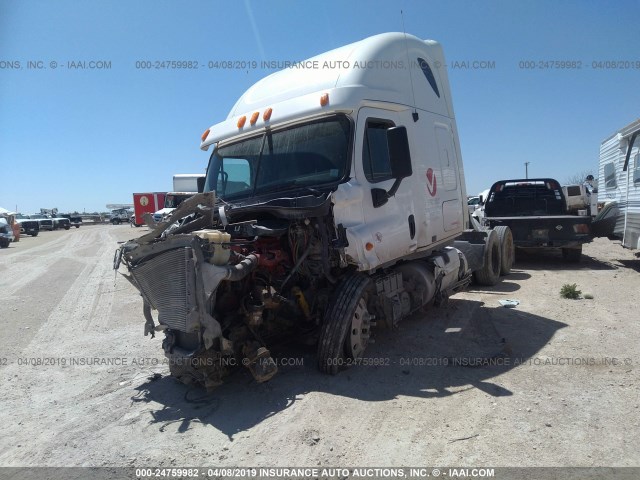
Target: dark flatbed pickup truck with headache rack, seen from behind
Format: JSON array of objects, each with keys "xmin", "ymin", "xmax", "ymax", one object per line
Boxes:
[{"xmin": 483, "ymin": 178, "xmax": 592, "ymax": 262}]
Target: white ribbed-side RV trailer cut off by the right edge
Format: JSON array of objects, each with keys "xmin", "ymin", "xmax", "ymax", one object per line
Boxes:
[{"xmin": 598, "ymin": 119, "xmax": 640, "ymax": 249}]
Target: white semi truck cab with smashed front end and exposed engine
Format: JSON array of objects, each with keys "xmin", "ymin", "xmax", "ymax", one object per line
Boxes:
[{"xmin": 116, "ymin": 33, "xmax": 504, "ymax": 388}]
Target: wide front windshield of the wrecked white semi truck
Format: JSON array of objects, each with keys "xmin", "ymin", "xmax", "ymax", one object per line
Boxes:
[{"xmin": 205, "ymin": 115, "xmax": 351, "ymax": 199}]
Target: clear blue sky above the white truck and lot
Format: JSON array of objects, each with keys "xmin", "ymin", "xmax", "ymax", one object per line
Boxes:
[{"xmin": 0, "ymin": 0, "xmax": 640, "ymax": 213}]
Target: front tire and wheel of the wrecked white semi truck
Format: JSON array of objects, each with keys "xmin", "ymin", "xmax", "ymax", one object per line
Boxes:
[{"xmin": 318, "ymin": 272, "xmax": 371, "ymax": 375}]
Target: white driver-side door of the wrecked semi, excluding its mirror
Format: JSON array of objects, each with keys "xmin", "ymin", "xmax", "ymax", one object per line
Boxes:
[{"xmin": 354, "ymin": 108, "xmax": 417, "ymax": 263}]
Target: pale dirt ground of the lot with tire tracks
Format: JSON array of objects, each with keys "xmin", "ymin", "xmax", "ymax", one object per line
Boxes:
[{"xmin": 0, "ymin": 225, "xmax": 640, "ymax": 467}]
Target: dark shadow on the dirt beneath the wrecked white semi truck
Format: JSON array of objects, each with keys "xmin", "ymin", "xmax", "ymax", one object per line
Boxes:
[{"xmin": 132, "ymin": 299, "xmax": 566, "ymax": 440}]
